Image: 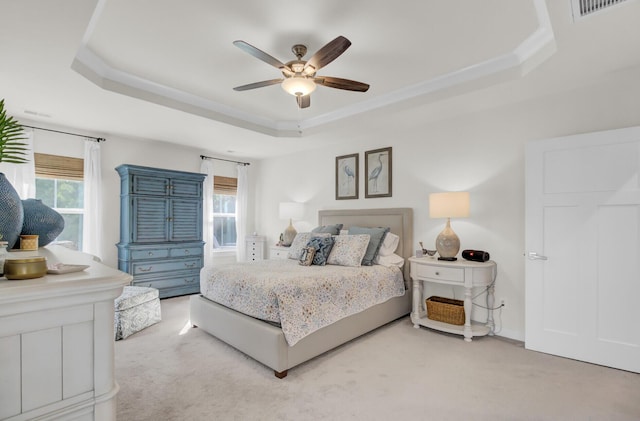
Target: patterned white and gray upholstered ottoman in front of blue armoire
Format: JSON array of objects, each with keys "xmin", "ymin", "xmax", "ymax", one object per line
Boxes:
[{"xmin": 115, "ymin": 286, "xmax": 162, "ymax": 341}]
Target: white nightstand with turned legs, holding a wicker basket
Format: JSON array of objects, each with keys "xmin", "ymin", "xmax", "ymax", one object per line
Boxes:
[{"xmin": 409, "ymin": 257, "xmax": 497, "ymax": 342}]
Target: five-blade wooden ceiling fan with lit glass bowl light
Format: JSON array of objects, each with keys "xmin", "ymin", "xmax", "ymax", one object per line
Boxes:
[{"xmin": 233, "ymin": 36, "xmax": 369, "ymax": 108}]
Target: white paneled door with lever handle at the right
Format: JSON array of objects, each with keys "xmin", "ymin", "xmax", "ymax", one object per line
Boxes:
[{"xmin": 525, "ymin": 127, "xmax": 640, "ymax": 373}]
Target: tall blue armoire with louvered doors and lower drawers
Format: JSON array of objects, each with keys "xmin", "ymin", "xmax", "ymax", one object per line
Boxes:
[{"xmin": 116, "ymin": 164, "xmax": 206, "ymax": 298}]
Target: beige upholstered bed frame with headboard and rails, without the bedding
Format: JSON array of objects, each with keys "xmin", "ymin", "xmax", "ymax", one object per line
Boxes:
[{"xmin": 190, "ymin": 208, "xmax": 413, "ymax": 378}]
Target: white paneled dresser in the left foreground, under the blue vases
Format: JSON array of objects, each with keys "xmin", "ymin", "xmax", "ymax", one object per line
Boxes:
[{"xmin": 0, "ymin": 246, "xmax": 131, "ymax": 421}]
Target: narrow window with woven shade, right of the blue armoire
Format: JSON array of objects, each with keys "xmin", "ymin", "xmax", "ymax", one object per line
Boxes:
[{"xmin": 213, "ymin": 176, "xmax": 238, "ymax": 249}]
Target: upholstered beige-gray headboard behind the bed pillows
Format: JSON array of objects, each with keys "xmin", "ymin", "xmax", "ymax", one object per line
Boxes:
[{"xmin": 318, "ymin": 208, "xmax": 415, "ymax": 281}]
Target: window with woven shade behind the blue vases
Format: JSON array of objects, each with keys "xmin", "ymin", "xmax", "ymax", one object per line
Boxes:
[{"xmin": 34, "ymin": 153, "xmax": 84, "ymax": 250}]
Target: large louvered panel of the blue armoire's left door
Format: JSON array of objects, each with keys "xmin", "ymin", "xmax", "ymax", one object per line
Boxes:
[{"xmin": 132, "ymin": 196, "xmax": 168, "ymax": 243}]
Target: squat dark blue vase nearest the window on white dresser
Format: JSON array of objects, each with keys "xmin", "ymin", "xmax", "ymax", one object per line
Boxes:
[{"xmin": 20, "ymin": 199, "xmax": 64, "ymax": 247}]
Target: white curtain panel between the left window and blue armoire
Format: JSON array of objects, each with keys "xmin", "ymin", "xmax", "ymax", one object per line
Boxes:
[{"xmin": 82, "ymin": 140, "xmax": 103, "ymax": 259}]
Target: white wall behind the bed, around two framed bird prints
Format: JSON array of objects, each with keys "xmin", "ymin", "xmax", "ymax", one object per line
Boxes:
[{"xmin": 252, "ymin": 73, "xmax": 640, "ymax": 340}]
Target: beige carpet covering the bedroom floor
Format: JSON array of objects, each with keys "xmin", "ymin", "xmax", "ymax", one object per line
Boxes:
[{"xmin": 116, "ymin": 297, "xmax": 640, "ymax": 421}]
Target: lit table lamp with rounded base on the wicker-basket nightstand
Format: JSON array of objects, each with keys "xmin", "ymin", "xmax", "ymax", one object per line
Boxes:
[{"xmin": 429, "ymin": 192, "xmax": 469, "ymax": 261}]
